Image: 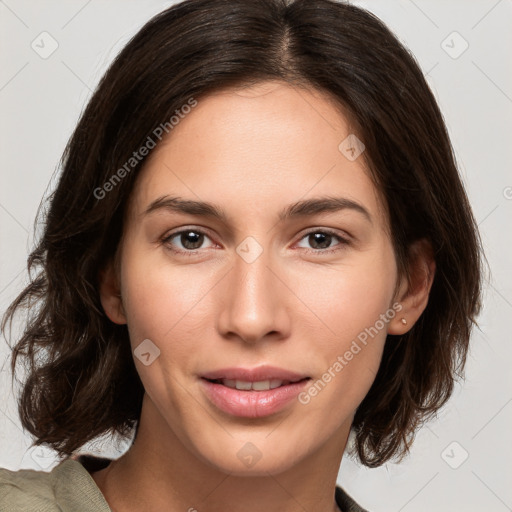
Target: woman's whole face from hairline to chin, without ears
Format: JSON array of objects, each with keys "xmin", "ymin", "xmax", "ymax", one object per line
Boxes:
[{"xmin": 114, "ymin": 82, "xmax": 400, "ymax": 474}]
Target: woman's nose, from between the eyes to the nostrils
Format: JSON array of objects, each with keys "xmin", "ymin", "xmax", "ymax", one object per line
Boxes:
[{"xmin": 217, "ymin": 243, "xmax": 293, "ymax": 344}]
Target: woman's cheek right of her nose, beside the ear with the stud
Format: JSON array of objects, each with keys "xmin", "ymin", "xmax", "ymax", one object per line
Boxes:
[{"xmin": 294, "ymin": 247, "xmax": 398, "ymax": 410}]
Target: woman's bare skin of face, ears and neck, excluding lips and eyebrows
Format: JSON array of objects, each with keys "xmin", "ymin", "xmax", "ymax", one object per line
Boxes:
[{"xmin": 92, "ymin": 81, "xmax": 435, "ymax": 512}]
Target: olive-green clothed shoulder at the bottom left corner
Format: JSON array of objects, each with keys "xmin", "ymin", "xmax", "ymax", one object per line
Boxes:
[{"xmin": 0, "ymin": 459, "xmax": 111, "ymax": 512}]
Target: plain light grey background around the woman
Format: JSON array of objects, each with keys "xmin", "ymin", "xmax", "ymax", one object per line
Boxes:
[{"xmin": 0, "ymin": 0, "xmax": 512, "ymax": 512}]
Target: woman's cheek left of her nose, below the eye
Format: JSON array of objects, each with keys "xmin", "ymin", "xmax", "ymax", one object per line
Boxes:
[{"xmin": 121, "ymin": 251, "xmax": 211, "ymax": 416}]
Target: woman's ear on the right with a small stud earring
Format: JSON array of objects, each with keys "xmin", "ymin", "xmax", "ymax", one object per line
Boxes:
[{"xmin": 388, "ymin": 238, "xmax": 436, "ymax": 335}]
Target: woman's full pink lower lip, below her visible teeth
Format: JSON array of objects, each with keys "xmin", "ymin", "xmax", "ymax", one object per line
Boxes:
[{"xmin": 201, "ymin": 378, "xmax": 310, "ymax": 418}]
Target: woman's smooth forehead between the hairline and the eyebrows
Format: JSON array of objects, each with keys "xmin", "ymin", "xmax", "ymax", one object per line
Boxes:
[{"xmin": 128, "ymin": 81, "xmax": 386, "ymax": 230}]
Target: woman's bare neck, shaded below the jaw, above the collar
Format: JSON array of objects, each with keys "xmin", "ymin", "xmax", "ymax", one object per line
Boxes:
[{"xmin": 92, "ymin": 395, "xmax": 350, "ymax": 512}]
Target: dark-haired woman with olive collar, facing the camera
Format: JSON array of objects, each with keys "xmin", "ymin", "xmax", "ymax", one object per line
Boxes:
[{"xmin": 0, "ymin": 0, "xmax": 481, "ymax": 512}]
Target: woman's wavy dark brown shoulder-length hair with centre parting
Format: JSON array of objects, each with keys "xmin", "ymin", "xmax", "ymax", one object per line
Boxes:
[{"xmin": 2, "ymin": 0, "xmax": 482, "ymax": 466}]
